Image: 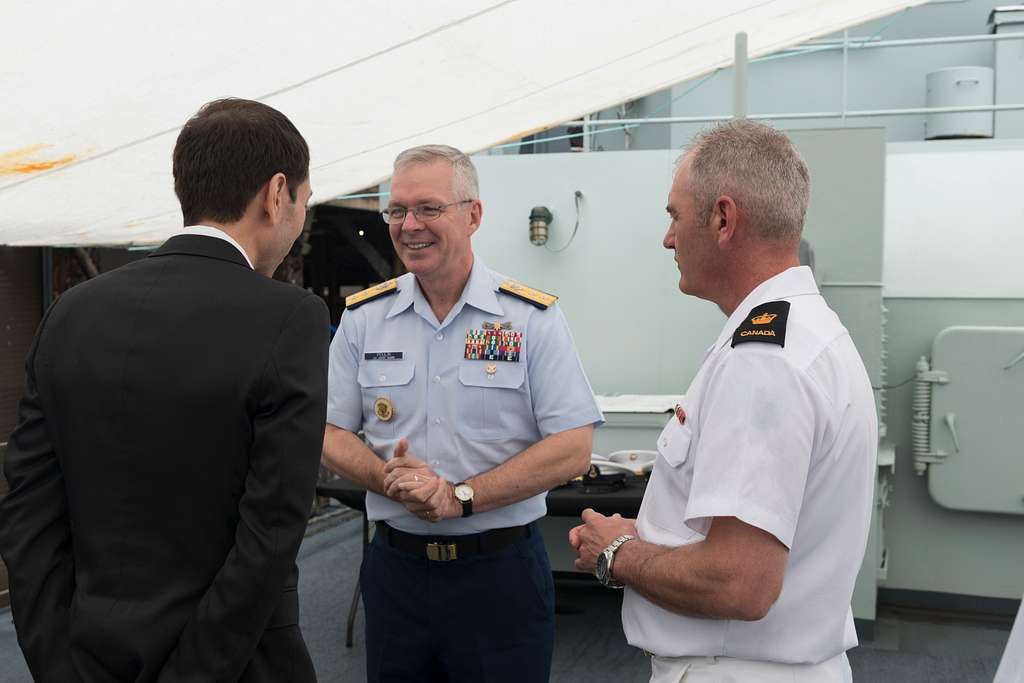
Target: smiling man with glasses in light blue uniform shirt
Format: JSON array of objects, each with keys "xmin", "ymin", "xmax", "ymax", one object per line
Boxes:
[{"xmin": 324, "ymin": 145, "xmax": 602, "ymax": 682}]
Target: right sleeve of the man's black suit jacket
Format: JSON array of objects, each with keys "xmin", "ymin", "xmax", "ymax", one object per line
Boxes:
[{"xmin": 157, "ymin": 295, "xmax": 328, "ymax": 683}]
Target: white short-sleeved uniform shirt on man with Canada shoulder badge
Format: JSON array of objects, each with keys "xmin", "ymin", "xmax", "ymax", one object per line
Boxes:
[{"xmin": 623, "ymin": 267, "xmax": 878, "ymax": 663}]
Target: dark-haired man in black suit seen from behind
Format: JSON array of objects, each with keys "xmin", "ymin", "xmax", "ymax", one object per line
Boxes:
[{"xmin": 0, "ymin": 99, "xmax": 329, "ymax": 683}]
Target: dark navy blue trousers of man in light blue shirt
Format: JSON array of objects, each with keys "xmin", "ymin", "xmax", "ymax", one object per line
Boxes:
[{"xmin": 359, "ymin": 523, "xmax": 555, "ymax": 683}]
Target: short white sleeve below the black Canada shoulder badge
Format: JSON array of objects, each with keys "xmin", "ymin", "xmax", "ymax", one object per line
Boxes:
[{"xmin": 684, "ymin": 344, "xmax": 818, "ymax": 548}]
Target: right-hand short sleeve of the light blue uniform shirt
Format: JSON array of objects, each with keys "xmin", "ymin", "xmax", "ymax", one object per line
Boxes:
[{"xmin": 526, "ymin": 304, "xmax": 604, "ymax": 437}]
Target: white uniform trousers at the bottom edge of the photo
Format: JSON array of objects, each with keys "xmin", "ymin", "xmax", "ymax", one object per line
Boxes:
[{"xmin": 650, "ymin": 652, "xmax": 853, "ymax": 683}]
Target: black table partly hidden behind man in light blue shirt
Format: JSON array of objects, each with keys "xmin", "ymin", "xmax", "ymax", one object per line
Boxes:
[{"xmin": 316, "ymin": 477, "xmax": 647, "ymax": 647}]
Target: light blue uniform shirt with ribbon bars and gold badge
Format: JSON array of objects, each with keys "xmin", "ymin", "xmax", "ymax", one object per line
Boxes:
[{"xmin": 327, "ymin": 259, "xmax": 603, "ymax": 535}]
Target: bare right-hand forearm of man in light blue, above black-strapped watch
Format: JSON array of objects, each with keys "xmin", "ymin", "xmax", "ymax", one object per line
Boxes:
[{"xmin": 468, "ymin": 425, "xmax": 594, "ymax": 512}]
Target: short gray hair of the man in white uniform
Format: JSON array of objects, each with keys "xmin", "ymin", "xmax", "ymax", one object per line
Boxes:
[{"xmin": 680, "ymin": 119, "xmax": 811, "ymax": 244}]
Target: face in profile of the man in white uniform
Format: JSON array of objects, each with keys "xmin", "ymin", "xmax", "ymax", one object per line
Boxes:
[{"xmin": 662, "ymin": 157, "xmax": 718, "ymax": 299}]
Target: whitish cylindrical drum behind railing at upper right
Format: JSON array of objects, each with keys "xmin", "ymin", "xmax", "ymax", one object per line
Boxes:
[{"xmin": 925, "ymin": 67, "xmax": 995, "ymax": 140}]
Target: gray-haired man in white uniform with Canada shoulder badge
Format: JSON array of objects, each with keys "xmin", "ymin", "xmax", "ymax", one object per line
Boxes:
[{"xmin": 569, "ymin": 121, "xmax": 878, "ymax": 683}]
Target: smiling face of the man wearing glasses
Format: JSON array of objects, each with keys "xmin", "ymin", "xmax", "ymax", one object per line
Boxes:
[{"xmin": 388, "ymin": 160, "xmax": 481, "ymax": 282}]
